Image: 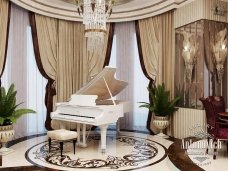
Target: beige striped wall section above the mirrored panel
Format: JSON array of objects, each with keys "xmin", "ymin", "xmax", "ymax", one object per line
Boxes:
[{"xmin": 174, "ymin": 0, "xmax": 228, "ymax": 28}]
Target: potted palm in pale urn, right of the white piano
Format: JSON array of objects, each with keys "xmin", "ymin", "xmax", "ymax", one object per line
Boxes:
[{"xmin": 139, "ymin": 84, "xmax": 180, "ymax": 138}]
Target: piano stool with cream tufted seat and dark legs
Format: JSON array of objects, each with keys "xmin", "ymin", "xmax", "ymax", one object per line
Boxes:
[{"xmin": 47, "ymin": 129, "xmax": 77, "ymax": 157}]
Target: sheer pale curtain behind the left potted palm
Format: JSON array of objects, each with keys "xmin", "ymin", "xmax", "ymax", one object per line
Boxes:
[{"xmin": 2, "ymin": 4, "xmax": 46, "ymax": 138}]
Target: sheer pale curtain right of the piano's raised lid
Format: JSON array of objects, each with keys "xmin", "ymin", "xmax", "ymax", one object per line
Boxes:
[{"xmin": 109, "ymin": 22, "xmax": 149, "ymax": 131}]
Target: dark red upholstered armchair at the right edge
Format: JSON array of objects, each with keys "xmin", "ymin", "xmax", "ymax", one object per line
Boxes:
[{"xmin": 200, "ymin": 96, "xmax": 228, "ymax": 159}]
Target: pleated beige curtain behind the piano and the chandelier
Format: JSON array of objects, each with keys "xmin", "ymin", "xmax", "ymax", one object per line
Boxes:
[{"xmin": 35, "ymin": 14, "xmax": 112, "ymax": 102}]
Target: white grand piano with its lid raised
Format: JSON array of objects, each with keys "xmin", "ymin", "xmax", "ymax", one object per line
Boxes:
[{"xmin": 51, "ymin": 67, "xmax": 130, "ymax": 152}]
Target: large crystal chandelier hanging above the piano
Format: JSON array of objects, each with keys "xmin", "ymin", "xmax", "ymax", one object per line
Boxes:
[{"xmin": 76, "ymin": 0, "xmax": 115, "ymax": 53}]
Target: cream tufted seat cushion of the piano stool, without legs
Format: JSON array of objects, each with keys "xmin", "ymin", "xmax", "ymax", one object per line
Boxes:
[{"xmin": 47, "ymin": 129, "xmax": 77, "ymax": 141}]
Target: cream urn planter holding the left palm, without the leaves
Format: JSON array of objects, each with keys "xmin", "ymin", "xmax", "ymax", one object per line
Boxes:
[{"xmin": 0, "ymin": 125, "xmax": 14, "ymax": 155}]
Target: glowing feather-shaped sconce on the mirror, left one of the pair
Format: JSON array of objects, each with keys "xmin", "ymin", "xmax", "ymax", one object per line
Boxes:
[{"xmin": 182, "ymin": 31, "xmax": 198, "ymax": 83}]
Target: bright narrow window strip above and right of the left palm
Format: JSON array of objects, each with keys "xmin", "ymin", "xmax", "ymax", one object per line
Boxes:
[{"xmin": 27, "ymin": 26, "xmax": 47, "ymax": 134}]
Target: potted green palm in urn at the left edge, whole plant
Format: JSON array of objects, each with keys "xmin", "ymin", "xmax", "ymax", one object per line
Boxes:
[{"xmin": 0, "ymin": 84, "xmax": 35, "ymax": 155}]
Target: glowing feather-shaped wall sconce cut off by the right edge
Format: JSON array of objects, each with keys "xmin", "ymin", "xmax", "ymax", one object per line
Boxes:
[{"xmin": 212, "ymin": 28, "xmax": 227, "ymax": 83}]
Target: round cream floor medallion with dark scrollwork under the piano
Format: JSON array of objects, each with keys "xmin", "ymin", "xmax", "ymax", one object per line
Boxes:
[{"xmin": 25, "ymin": 134, "xmax": 167, "ymax": 170}]
